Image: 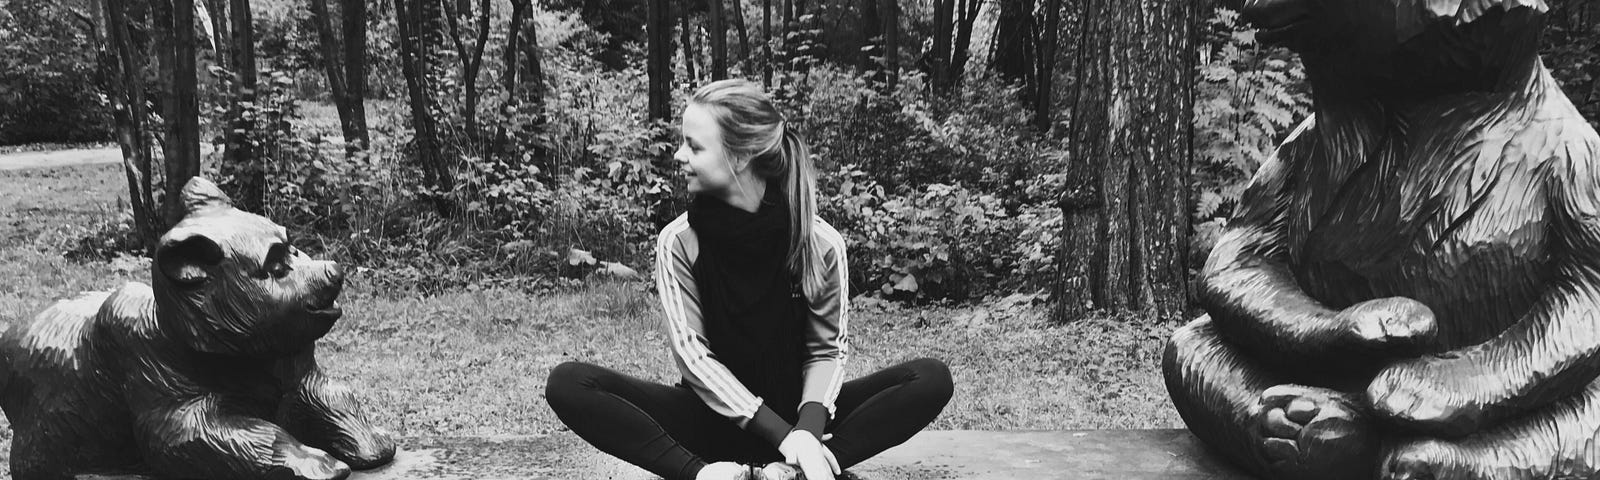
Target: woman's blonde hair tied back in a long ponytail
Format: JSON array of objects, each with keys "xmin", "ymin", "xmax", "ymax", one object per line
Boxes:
[{"xmin": 690, "ymin": 78, "xmax": 822, "ymax": 285}]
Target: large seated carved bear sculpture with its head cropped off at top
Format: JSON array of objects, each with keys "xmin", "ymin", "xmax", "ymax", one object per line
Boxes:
[{"xmin": 1163, "ymin": 0, "xmax": 1600, "ymax": 480}]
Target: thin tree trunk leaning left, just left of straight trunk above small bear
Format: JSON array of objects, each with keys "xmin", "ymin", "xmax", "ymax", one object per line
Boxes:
[{"xmin": 99, "ymin": 0, "xmax": 158, "ymax": 254}]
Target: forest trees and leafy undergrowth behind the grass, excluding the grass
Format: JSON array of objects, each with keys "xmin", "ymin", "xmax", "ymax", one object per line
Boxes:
[{"xmin": 9, "ymin": 0, "xmax": 1600, "ymax": 315}]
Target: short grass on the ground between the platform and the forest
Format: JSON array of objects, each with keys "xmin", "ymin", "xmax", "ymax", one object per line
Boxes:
[{"xmin": 0, "ymin": 159, "xmax": 1182, "ymax": 478}]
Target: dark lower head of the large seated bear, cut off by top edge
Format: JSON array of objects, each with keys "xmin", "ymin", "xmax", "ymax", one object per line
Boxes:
[{"xmin": 1240, "ymin": 0, "xmax": 1549, "ymax": 98}]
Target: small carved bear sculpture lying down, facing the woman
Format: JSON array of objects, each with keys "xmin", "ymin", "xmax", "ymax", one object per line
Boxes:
[{"xmin": 0, "ymin": 178, "xmax": 395, "ymax": 480}]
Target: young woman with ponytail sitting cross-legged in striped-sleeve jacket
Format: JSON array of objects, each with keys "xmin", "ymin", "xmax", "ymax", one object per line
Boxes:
[{"xmin": 546, "ymin": 80, "xmax": 952, "ymax": 480}]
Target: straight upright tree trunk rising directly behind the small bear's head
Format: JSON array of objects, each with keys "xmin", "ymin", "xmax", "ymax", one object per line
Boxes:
[{"xmin": 152, "ymin": 0, "xmax": 204, "ymax": 225}]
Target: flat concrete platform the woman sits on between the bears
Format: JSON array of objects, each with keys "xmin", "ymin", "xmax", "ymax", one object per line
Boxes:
[{"xmin": 350, "ymin": 430, "xmax": 1250, "ymax": 480}]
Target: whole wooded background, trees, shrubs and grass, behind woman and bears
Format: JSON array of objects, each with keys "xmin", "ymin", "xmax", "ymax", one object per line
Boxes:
[{"xmin": 0, "ymin": 0, "xmax": 1600, "ymax": 473}]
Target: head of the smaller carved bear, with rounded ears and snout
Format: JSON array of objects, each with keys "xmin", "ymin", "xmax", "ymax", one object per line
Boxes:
[{"xmin": 152, "ymin": 178, "xmax": 344, "ymax": 357}]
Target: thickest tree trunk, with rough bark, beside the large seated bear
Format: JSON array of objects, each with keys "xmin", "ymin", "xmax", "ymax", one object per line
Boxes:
[{"xmin": 1040, "ymin": 0, "xmax": 1194, "ymax": 320}]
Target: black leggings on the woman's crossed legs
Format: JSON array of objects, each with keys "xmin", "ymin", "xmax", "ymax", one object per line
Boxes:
[{"xmin": 544, "ymin": 358, "xmax": 952, "ymax": 478}]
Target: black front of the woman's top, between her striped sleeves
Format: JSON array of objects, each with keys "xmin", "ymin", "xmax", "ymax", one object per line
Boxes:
[{"xmin": 688, "ymin": 186, "xmax": 805, "ymax": 421}]
